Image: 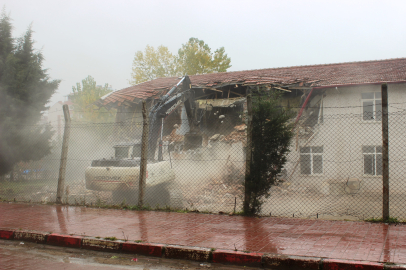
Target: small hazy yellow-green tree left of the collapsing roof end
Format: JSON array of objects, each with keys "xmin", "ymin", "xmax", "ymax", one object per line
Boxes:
[{"xmin": 72, "ymin": 75, "xmax": 115, "ymax": 122}]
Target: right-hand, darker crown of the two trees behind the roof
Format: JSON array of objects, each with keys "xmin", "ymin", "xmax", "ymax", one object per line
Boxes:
[{"xmin": 176, "ymin": 38, "xmax": 231, "ymax": 75}]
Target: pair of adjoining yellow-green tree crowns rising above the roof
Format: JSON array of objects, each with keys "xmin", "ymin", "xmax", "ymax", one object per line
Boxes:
[{"xmin": 129, "ymin": 38, "xmax": 231, "ymax": 85}]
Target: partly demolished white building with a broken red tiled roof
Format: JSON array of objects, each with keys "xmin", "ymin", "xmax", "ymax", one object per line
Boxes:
[{"xmin": 98, "ymin": 58, "xmax": 406, "ymax": 194}]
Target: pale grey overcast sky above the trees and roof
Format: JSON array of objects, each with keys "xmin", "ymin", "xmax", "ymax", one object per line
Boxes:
[{"xmin": 1, "ymin": 0, "xmax": 406, "ymax": 104}]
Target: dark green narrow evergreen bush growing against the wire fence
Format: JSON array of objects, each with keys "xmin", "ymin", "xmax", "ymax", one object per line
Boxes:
[{"xmin": 244, "ymin": 92, "xmax": 293, "ymax": 215}]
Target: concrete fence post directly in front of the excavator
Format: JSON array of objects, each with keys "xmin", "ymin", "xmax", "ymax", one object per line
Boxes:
[{"xmin": 138, "ymin": 100, "xmax": 149, "ymax": 207}]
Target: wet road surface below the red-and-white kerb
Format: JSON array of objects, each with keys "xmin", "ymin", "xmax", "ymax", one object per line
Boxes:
[{"xmin": 0, "ymin": 240, "xmax": 258, "ymax": 270}]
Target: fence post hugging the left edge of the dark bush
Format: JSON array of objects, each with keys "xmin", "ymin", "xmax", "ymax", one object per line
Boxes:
[{"xmin": 243, "ymin": 94, "xmax": 252, "ymax": 213}]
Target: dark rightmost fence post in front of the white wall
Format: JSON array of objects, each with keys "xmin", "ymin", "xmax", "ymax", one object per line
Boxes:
[{"xmin": 381, "ymin": 83, "xmax": 389, "ymax": 221}]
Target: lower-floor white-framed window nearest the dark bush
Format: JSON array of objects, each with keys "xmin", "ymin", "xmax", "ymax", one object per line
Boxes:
[{"xmin": 300, "ymin": 146, "xmax": 323, "ymax": 175}]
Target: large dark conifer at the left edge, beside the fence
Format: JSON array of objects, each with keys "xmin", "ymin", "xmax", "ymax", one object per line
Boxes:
[{"xmin": 0, "ymin": 9, "xmax": 60, "ymax": 175}]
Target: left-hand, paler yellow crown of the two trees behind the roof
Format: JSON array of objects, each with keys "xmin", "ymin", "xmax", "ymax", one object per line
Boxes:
[{"xmin": 130, "ymin": 45, "xmax": 176, "ymax": 85}]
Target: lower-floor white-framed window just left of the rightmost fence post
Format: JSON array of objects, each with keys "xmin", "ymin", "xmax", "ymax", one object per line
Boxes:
[{"xmin": 362, "ymin": 145, "xmax": 382, "ymax": 175}]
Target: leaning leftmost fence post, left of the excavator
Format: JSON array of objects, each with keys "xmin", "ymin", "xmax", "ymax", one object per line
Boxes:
[{"xmin": 56, "ymin": 104, "xmax": 70, "ymax": 204}]
